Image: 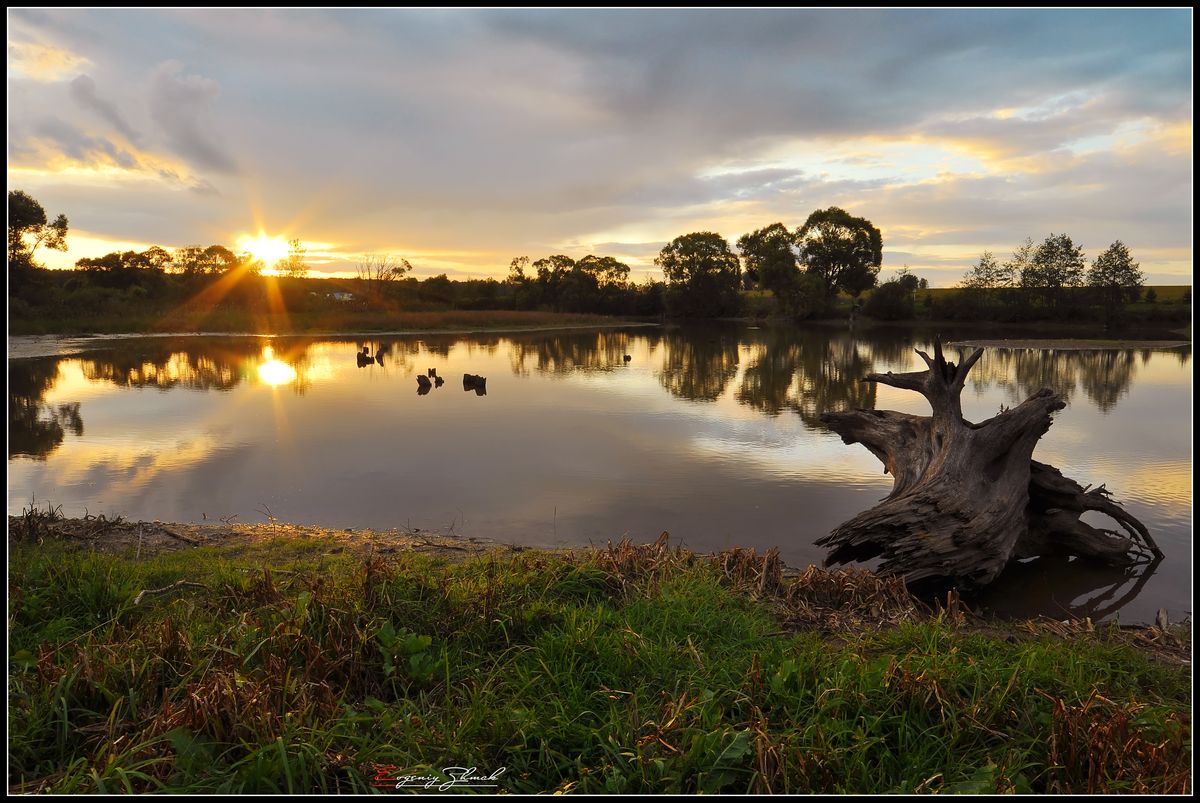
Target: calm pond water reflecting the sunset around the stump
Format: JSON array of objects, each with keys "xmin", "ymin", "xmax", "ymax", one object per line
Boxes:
[{"xmin": 8, "ymin": 328, "xmax": 1192, "ymax": 622}]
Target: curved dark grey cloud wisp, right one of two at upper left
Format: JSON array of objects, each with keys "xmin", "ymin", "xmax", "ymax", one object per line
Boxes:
[{"xmin": 150, "ymin": 61, "xmax": 236, "ymax": 174}]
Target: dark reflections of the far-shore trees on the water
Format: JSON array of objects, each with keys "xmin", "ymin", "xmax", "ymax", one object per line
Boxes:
[{"xmin": 8, "ymin": 325, "xmax": 1190, "ymax": 457}]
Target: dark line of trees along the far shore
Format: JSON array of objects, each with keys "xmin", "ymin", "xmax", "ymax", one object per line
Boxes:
[{"xmin": 8, "ymin": 190, "xmax": 1190, "ymax": 323}]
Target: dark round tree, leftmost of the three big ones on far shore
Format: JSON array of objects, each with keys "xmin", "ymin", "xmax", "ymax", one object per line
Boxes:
[{"xmin": 654, "ymin": 232, "xmax": 742, "ymax": 318}]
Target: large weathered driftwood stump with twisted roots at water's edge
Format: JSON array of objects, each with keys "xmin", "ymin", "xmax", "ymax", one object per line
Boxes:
[{"xmin": 817, "ymin": 340, "xmax": 1162, "ymax": 586}]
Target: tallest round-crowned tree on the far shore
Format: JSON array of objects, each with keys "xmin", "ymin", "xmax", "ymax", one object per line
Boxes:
[{"xmin": 794, "ymin": 206, "xmax": 883, "ymax": 299}]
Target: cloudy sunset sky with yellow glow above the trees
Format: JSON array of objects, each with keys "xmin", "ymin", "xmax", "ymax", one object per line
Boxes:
[{"xmin": 7, "ymin": 8, "xmax": 1193, "ymax": 287}]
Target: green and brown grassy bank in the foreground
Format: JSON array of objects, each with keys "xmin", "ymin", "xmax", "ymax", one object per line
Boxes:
[{"xmin": 8, "ymin": 517, "xmax": 1190, "ymax": 792}]
